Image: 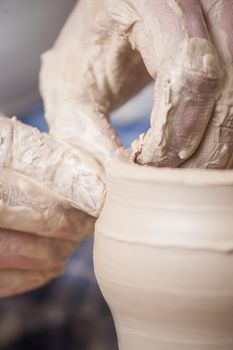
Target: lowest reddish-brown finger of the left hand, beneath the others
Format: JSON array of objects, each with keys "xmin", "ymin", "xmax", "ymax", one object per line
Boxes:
[{"xmin": 0, "ymin": 270, "xmax": 61, "ymax": 297}]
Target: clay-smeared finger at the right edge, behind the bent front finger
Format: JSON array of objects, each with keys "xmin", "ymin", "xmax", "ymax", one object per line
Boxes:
[{"xmin": 184, "ymin": 0, "xmax": 233, "ymax": 169}]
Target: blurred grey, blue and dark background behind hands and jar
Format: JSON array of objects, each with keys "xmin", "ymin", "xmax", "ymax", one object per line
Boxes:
[{"xmin": 0, "ymin": 0, "xmax": 153, "ymax": 350}]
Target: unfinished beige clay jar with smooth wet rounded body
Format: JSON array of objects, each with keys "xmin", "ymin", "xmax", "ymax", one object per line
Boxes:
[{"xmin": 94, "ymin": 159, "xmax": 233, "ymax": 350}]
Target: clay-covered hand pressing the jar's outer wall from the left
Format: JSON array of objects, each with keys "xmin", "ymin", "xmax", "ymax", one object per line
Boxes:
[{"xmin": 0, "ymin": 117, "xmax": 105, "ymax": 297}]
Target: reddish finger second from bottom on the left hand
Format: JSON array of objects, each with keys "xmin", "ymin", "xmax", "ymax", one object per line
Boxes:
[{"xmin": 0, "ymin": 229, "xmax": 76, "ymax": 271}]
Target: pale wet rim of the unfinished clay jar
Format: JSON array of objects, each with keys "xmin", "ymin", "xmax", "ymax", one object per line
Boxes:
[{"xmin": 107, "ymin": 149, "xmax": 233, "ymax": 186}]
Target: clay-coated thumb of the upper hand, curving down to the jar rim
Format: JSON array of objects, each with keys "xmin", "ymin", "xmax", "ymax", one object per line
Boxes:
[{"xmin": 40, "ymin": 0, "xmax": 150, "ymax": 165}]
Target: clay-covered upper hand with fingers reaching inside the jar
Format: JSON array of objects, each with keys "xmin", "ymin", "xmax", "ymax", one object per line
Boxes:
[{"xmin": 41, "ymin": 0, "xmax": 233, "ymax": 168}]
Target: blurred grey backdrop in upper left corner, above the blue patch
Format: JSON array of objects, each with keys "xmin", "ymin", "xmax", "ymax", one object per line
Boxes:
[{"xmin": 0, "ymin": 0, "xmax": 76, "ymax": 115}]
